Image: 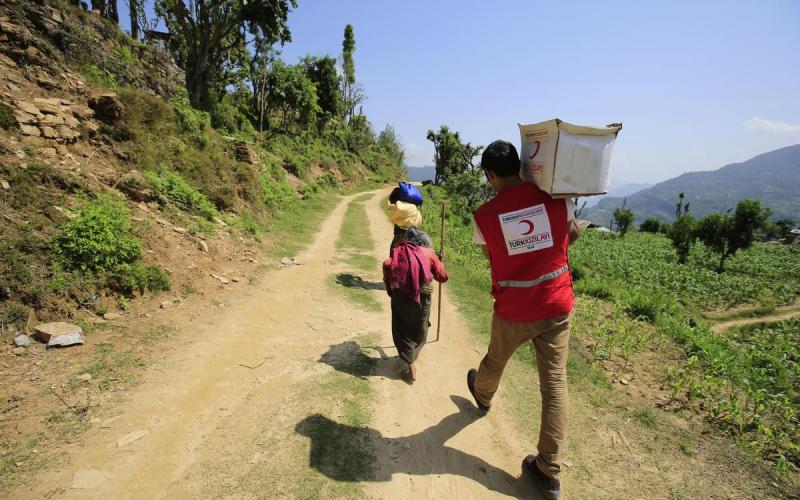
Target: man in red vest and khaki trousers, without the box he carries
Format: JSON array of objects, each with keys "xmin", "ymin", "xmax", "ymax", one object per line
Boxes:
[{"xmin": 467, "ymin": 141, "xmax": 579, "ymax": 498}]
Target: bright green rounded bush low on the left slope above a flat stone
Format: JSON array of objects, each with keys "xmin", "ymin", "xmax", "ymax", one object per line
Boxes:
[{"xmin": 56, "ymin": 196, "xmax": 141, "ymax": 272}]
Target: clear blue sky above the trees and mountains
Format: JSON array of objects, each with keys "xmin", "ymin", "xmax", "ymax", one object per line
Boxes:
[{"xmin": 120, "ymin": 0, "xmax": 800, "ymax": 184}]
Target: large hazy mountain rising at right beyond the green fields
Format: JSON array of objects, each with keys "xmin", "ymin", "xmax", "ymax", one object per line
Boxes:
[{"xmin": 584, "ymin": 144, "xmax": 800, "ymax": 225}]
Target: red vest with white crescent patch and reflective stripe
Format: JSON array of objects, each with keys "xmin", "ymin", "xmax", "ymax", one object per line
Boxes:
[{"xmin": 475, "ymin": 183, "xmax": 574, "ymax": 321}]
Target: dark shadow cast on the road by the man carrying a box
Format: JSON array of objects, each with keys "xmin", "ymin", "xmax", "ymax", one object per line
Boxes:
[{"xmin": 295, "ymin": 396, "xmax": 537, "ymax": 498}]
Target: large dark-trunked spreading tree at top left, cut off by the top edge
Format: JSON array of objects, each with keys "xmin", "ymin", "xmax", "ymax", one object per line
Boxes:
[{"xmin": 156, "ymin": 0, "xmax": 297, "ymax": 111}]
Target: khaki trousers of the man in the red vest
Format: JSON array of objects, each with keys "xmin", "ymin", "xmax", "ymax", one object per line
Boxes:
[{"xmin": 475, "ymin": 313, "xmax": 572, "ymax": 478}]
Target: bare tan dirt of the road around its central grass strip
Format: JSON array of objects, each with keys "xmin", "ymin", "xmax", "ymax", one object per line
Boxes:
[{"xmin": 10, "ymin": 189, "xmax": 522, "ymax": 498}]
